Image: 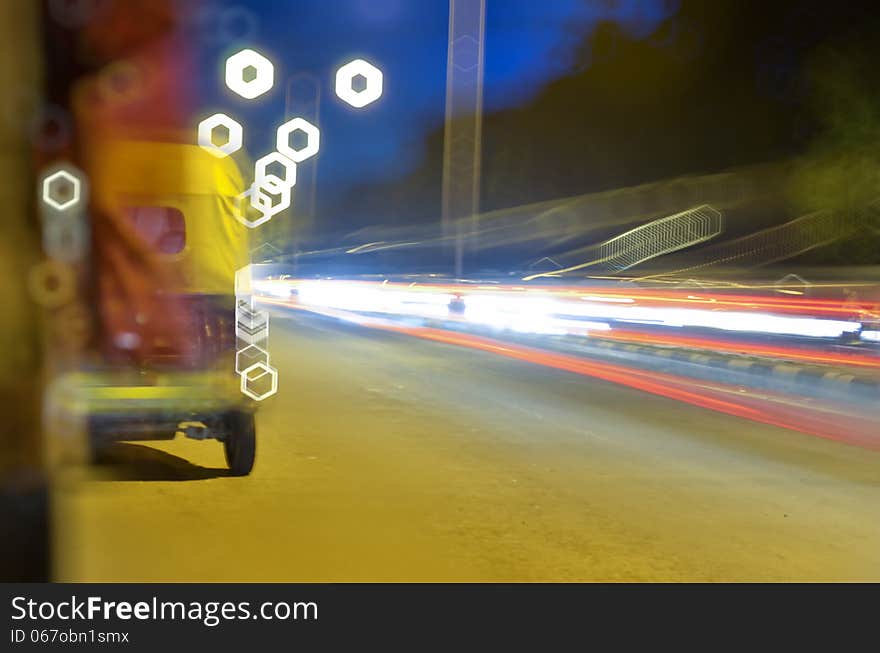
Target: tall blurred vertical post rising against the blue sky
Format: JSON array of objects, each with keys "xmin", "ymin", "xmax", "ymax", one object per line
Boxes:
[{"xmin": 442, "ymin": 0, "xmax": 486, "ymax": 277}]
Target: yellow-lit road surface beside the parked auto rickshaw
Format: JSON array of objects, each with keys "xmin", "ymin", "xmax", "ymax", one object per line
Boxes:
[{"xmin": 54, "ymin": 313, "xmax": 880, "ymax": 581}]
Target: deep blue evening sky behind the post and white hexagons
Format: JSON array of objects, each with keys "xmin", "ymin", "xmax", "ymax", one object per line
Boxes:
[{"xmin": 192, "ymin": 0, "xmax": 674, "ymax": 194}]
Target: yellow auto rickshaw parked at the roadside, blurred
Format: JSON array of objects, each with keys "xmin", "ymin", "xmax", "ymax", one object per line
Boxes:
[{"xmin": 45, "ymin": 138, "xmax": 256, "ymax": 475}]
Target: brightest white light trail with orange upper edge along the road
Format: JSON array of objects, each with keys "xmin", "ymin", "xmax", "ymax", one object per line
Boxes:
[{"xmin": 256, "ymin": 280, "xmax": 875, "ymax": 339}]
